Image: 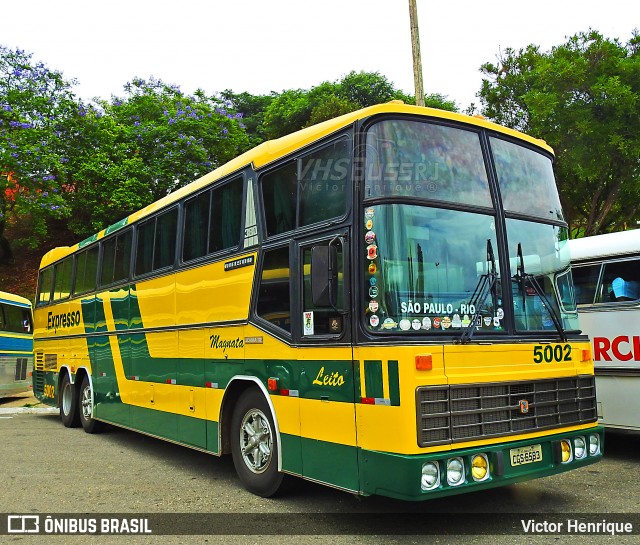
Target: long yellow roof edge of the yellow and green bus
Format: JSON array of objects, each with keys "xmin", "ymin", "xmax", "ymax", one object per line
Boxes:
[{"xmin": 40, "ymin": 100, "xmax": 553, "ymax": 268}]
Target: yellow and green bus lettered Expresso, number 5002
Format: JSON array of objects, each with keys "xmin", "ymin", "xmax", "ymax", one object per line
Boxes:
[{"xmin": 34, "ymin": 103, "xmax": 603, "ymax": 500}]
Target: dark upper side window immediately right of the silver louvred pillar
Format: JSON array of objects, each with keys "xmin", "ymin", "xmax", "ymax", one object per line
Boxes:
[{"xmin": 262, "ymin": 161, "xmax": 297, "ymax": 236}]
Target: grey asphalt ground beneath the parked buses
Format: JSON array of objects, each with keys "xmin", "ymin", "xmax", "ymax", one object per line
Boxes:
[{"xmin": 0, "ymin": 409, "xmax": 640, "ymax": 545}]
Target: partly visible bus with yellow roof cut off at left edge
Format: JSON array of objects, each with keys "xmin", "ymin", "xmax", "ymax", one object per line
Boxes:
[{"xmin": 0, "ymin": 291, "xmax": 33, "ymax": 397}]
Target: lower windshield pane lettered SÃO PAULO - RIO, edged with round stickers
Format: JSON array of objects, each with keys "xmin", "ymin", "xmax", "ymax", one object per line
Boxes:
[{"xmin": 365, "ymin": 204, "xmax": 504, "ymax": 332}]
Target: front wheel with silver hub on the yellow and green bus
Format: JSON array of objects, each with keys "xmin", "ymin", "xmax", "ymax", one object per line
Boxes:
[{"xmin": 231, "ymin": 388, "xmax": 283, "ymax": 498}]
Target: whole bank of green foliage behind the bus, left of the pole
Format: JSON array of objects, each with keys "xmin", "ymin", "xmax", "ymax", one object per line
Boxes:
[{"xmin": 0, "ymin": 47, "xmax": 455, "ymax": 260}]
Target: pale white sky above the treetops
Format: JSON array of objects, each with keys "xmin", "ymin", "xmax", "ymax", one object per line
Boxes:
[{"xmin": 0, "ymin": 0, "xmax": 640, "ymax": 109}]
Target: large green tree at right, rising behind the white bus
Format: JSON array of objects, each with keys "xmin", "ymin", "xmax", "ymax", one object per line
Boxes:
[{"xmin": 480, "ymin": 31, "xmax": 640, "ymax": 235}]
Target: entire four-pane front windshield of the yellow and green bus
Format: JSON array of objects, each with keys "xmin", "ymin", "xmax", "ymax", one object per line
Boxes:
[{"xmin": 364, "ymin": 120, "xmax": 578, "ymax": 334}]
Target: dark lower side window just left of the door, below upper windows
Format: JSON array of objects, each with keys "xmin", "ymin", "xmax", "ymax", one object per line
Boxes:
[{"xmin": 257, "ymin": 246, "xmax": 291, "ymax": 333}]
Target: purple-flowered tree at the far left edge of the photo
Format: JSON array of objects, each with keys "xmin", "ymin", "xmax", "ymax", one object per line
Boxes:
[{"xmin": 0, "ymin": 46, "xmax": 79, "ymax": 262}]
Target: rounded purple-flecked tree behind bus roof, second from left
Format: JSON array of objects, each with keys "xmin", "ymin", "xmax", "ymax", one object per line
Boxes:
[{"xmin": 66, "ymin": 78, "xmax": 249, "ymax": 234}]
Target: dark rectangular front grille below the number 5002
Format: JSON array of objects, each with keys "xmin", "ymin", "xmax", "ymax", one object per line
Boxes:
[{"xmin": 416, "ymin": 375, "xmax": 597, "ymax": 447}]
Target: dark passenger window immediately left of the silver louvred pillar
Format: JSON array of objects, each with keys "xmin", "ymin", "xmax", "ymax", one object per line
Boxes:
[{"xmin": 209, "ymin": 178, "xmax": 244, "ymax": 253}]
